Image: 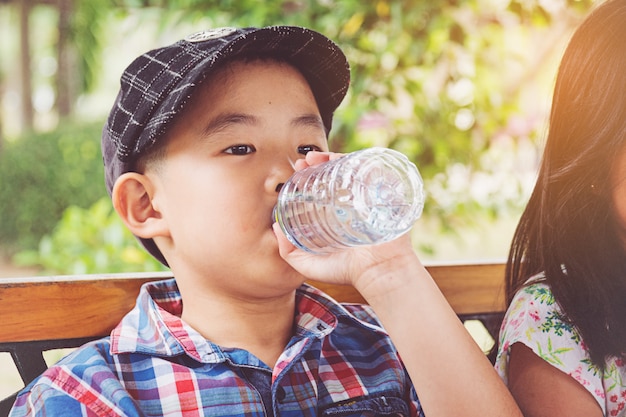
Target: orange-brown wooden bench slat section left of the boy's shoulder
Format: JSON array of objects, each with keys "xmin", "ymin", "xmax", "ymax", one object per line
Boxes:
[{"xmin": 0, "ymin": 273, "xmax": 171, "ymax": 342}]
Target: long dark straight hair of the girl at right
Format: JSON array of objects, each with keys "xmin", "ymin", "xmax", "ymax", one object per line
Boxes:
[{"xmin": 506, "ymin": 0, "xmax": 626, "ymax": 369}]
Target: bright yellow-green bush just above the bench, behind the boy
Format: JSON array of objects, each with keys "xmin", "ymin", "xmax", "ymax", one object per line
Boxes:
[{"xmin": 14, "ymin": 197, "xmax": 165, "ymax": 274}]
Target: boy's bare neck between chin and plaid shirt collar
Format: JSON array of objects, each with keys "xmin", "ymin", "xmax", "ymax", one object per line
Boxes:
[{"xmin": 177, "ymin": 286, "xmax": 295, "ymax": 368}]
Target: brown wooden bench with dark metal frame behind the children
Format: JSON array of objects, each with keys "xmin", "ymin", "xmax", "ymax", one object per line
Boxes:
[{"xmin": 0, "ymin": 262, "xmax": 505, "ymax": 417}]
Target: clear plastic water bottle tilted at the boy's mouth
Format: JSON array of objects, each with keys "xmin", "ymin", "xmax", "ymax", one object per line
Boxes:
[{"xmin": 274, "ymin": 148, "xmax": 424, "ymax": 254}]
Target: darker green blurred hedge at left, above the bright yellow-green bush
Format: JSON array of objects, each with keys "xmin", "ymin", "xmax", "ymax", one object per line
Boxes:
[{"xmin": 0, "ymin": 119, "xmax": 106, "ymax": 251}]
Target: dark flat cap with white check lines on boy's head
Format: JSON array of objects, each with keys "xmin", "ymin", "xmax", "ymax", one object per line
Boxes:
[{"xmin": 102, "ymin": 26, "xmax": 350, "ymax": 265}]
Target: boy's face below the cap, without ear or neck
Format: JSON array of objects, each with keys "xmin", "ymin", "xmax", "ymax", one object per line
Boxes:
[{"xmin": 146, "ymin": 60, "xmax": 328, "ymax": 296}]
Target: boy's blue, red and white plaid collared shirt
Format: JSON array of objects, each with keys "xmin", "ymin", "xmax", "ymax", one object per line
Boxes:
[{"xmin": 10, "ymin": 279, "xmax": 423, "ymax": 417}]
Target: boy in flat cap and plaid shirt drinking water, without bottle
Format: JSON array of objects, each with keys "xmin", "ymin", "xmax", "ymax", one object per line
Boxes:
[{"xmin": 12, "ymin": 27, "xmax": 515, "ymax": 417}]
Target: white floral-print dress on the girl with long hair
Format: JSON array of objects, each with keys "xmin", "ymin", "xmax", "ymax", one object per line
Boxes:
[{"xmin": 495, "ymin": 276, "xmax": 626, "ymax": 417}]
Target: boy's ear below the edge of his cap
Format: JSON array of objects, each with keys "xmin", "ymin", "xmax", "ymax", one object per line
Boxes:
[{"xmin": 111, "ymin": 172, "xmax": 167, "ymax": 239}]
